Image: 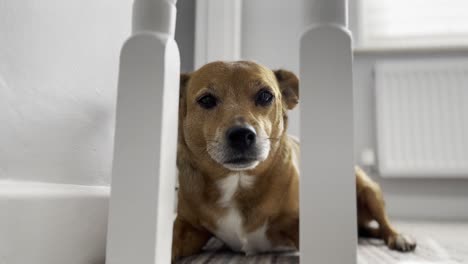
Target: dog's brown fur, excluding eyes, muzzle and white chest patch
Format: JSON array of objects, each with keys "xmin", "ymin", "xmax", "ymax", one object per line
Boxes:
[{"xmin": 172, "ymin": 61, "xmax": 415, "ymax": 260}]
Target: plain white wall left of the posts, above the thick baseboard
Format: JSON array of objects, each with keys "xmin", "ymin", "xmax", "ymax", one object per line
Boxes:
[{"xmin": 0, "ymin": 0, "xmax": 132, "ymax": 185}]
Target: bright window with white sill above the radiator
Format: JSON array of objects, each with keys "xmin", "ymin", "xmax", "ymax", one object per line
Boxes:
[{"xmin": 358, "ymin": 0, "xmax": 468, "ymax": 48}]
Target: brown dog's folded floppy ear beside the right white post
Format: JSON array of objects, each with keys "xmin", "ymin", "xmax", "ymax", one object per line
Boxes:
[{"xmin": 273, "ymin": 69, "xmax": 299, "ymax": 109}]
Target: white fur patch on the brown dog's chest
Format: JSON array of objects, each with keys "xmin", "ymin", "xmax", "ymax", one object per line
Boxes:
[{"xmin": 215, "ymin": 172, "xmax": 272, "ymax": 254}]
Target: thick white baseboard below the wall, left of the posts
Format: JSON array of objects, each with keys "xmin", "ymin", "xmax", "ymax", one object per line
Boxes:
[{"xmin": 0, "ymin": 181, "xmax": 109, "ymax": 264}]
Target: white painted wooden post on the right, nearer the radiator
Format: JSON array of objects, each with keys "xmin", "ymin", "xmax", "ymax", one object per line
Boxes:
[{"xmin": 300, "ymin": 0, "xmax": 357, "ymax": 264}]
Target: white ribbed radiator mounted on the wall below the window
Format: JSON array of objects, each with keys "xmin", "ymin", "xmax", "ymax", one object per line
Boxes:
[{"xmin": 375, "ymin": 60, "xmax": 468, "ymax": 178}]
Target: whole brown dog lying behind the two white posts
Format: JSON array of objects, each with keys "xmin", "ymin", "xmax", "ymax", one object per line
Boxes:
[{"xmin": 172, "ymin": 61, "xmax": 415, "ymax": 260}]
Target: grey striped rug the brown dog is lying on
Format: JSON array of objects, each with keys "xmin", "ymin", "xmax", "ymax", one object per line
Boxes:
[{"xmin": 177, "ymin": 221, "xmax": 468, "ymax": 264}]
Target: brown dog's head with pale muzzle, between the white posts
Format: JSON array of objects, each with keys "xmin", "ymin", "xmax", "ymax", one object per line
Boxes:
[{"xmin": 179, "ymin": 61, "xmax": 299, "ymax": 171}]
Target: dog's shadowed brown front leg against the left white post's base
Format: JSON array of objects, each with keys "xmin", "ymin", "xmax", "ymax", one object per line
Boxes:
[{"xmin": 172, "ymin": 217, "xmax": 212, "ymax": 263}]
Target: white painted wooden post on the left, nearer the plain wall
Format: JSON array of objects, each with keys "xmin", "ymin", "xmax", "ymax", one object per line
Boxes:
[{"xmin": 106, "ymin": 0, "xmax": 180, "ymax": 264}]
